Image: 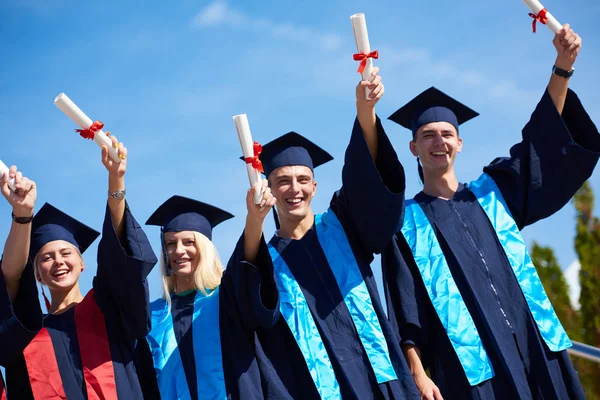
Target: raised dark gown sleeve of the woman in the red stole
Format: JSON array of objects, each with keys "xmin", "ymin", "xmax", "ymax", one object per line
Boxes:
[{"xmin": 93, "ymin": 205, "xmax": 158, "ymax": 342}]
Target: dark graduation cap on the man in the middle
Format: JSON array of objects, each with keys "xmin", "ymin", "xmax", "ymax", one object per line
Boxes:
[{"xmin": 259, "ymin": 132, "xmax": 333, "ymax": 177}]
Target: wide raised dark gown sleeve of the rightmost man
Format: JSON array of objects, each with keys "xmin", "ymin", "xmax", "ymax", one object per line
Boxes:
[{"xmin": 484, "ymin": 90, "xmax": 600, "ymax": 229}]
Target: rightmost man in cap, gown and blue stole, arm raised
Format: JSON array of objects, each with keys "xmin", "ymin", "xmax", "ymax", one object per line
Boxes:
[{"xmin": 382, "ymin": 26, "xmax": 600, "ymax": 400}]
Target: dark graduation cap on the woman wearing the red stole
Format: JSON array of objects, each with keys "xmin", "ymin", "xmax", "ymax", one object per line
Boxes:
[{"xmin": 29, "ymin": 203, "xmax": 100, "ymax": 260}]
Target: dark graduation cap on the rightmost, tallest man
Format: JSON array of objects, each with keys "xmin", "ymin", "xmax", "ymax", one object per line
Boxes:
[{"xmin": 388, "ymin": 86, "xmax": 479, "ymax": 137}]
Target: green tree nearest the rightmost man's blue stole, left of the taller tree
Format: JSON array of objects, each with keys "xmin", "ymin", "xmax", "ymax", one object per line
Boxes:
[{"xmin": 531, "ymin": 242, "xmax": 581, "ymax": 340}]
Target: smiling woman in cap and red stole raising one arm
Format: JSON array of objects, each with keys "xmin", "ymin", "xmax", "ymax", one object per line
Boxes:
[{"xmin": 1, "ymin": 136, "xmax": 157, "ymax": 400}]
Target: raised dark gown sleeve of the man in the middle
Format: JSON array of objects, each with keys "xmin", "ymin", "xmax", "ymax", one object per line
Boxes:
[{"xmin": 331, "ymin": 117, "xmax": 405, "ymax": 254}]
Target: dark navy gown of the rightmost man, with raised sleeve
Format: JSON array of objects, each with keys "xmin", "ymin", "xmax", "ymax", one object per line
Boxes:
[{"xmin": 382, "ymin": 91, "xmax": 600, "ymax": 399}]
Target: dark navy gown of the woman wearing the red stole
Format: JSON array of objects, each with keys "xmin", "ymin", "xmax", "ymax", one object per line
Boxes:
[{"xmin": 6, "ymin": 206, "xmax": 157, "ymax": 400}]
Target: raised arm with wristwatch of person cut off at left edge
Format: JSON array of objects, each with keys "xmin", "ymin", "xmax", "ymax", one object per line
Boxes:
[{"xmin": 0, "ymin": 166, "xmax": 42, "ymax": 400}]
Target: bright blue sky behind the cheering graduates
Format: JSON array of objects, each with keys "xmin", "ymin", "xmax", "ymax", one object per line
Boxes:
[{"xmin": 0, "ymin": 0, "xmax": 600, "ymax": 310}]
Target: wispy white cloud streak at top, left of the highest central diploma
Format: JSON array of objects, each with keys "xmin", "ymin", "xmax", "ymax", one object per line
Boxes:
[{"xmin": 192, "ymin": 0, "xmax": 343, "ymax": 51}]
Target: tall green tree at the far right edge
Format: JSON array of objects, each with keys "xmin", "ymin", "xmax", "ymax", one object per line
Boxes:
[{"xmin": 573, "ymin": 182, "xmax": 600, "ymax": 399}]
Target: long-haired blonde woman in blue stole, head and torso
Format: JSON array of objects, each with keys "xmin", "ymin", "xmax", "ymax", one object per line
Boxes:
[{"xmin": 141, "ymin": 196, "xmax": 246, "ymax": 399}]
